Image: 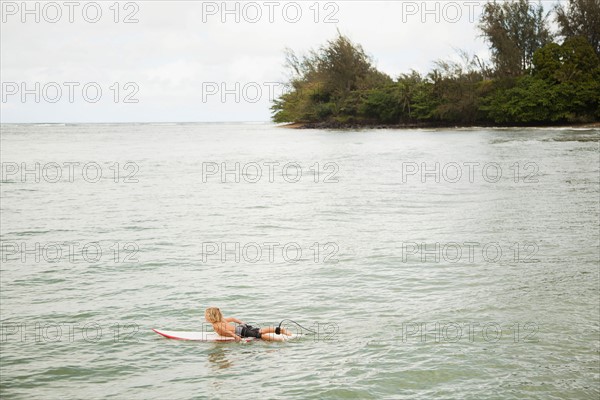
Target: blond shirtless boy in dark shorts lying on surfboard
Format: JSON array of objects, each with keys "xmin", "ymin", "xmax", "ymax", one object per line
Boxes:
[{"xmin": 204, "ymin": 307, "xmax": 292, "ymax": 342}]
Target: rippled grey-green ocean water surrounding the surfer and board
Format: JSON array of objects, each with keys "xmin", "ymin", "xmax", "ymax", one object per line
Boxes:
[{"xmin": 0, "ymin": 123, "xmax": 600, "ymax": 399}]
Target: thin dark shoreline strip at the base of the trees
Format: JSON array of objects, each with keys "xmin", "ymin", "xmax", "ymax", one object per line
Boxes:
[{"xmin": 278, "ymin": 122, "xmax": 600, "ymax": 130}]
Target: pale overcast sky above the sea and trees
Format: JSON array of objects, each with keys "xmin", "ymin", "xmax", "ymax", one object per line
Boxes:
[{"xmin": 0, "ymin": 0, "xmax": 555, "ymax": 122}]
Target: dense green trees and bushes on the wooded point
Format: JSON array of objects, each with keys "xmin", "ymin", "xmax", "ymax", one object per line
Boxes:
[{"xmin": 272, "ymin": 0, "xmax": 600, "ymax": 126}]
